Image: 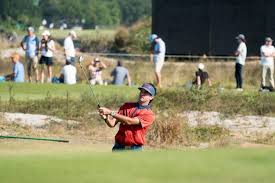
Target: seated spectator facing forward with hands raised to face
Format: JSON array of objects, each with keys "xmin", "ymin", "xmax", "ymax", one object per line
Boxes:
[{"xmin": 88, "ymin": 57, "xmax": 107, "ymax": 85}]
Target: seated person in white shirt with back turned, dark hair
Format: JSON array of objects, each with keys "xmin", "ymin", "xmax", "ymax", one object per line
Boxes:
[{"xmin": 60, "ymin": 60, "xmax": 77, "ymax": 85}]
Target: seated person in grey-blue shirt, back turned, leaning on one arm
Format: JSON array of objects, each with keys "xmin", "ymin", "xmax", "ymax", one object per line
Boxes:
[{"xmin": 111, "ymin": 61, "xmax": 131, "ymax": 86}]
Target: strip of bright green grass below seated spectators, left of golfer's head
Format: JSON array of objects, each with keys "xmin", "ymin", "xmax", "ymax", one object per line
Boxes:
[{"xmin": 0, "ymin": 83, "xmax": 138, "ymax": 101}]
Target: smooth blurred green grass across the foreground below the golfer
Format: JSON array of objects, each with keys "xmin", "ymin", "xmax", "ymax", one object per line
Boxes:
[{"xmin": 0, "ymin": 145, "xmax": 275, "ymax": 183}]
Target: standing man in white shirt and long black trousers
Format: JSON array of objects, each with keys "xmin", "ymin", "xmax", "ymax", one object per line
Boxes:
[{"xmin": 235, "ymin": 34, "xmax": 247, "ymax": 91}]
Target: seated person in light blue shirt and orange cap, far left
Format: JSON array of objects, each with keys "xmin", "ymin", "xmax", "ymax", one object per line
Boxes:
[{"xmin": 4, "ymin": 53, "xmax": 25, "ymax": 83}]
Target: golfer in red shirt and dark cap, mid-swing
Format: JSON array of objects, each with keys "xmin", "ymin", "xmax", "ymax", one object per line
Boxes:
[{"xmin": 98, "ymin": 83, "xmax": 157, "ymax": 151}]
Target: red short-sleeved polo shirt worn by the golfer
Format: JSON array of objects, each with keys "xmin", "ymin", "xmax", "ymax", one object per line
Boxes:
[{"xmin": 115, "ymin": 103, "xmax": 155, "ymax": 146}]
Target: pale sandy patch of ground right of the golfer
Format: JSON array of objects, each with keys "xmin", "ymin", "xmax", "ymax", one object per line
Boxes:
[{"xmin": 181, "ymin": 111, "xmax": 275, "ymax": 139}]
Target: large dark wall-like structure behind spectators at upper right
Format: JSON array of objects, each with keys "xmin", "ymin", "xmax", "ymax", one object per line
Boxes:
[{"xmin": 152, "ymin": 0, "xmax": 275, "ymax": 56}]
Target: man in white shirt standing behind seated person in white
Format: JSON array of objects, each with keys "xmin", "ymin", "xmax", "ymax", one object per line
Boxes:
[{"xmin": 64, "ymin": 31, "xmax": 76, "ymax": 65}]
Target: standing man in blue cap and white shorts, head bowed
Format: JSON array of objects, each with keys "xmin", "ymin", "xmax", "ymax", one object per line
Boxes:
[{"xmin": 149, "ymin": 34, "xmax": 166, "ymax": 88}]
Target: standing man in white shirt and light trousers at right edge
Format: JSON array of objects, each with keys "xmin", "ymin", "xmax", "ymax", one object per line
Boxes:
[{"xmin": 261, "ymin": 37, "xmax": 275, "ymax": 89}]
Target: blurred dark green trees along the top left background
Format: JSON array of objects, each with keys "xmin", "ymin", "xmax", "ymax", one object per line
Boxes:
[{"xmin": 0, "ymin": 0, "xmax": 151, "ymax": 28}]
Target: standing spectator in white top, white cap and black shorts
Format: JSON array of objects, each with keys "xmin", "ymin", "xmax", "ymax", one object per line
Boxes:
[{"xmin": 39, "ymin": 30, "xmax": 55, "ymax": 83}]
